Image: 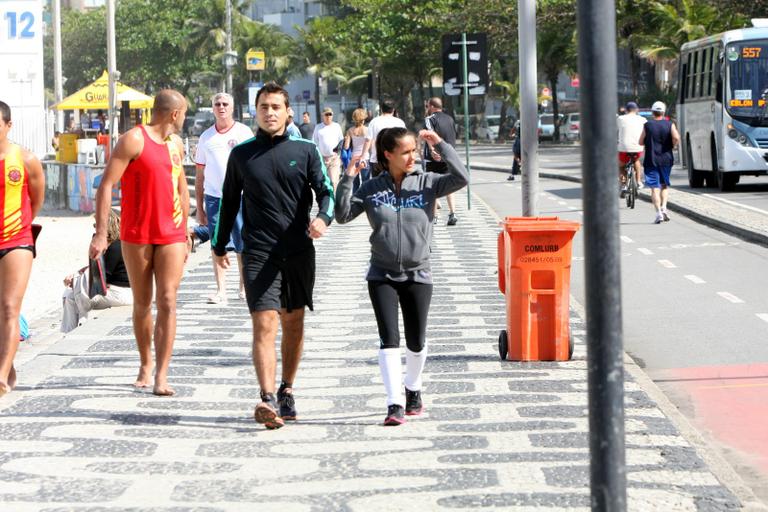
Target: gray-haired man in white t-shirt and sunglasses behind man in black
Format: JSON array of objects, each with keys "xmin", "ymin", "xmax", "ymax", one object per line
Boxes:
[{"xmin": 193, "ymin": 92, "xmax": 253, "ymax": 304}]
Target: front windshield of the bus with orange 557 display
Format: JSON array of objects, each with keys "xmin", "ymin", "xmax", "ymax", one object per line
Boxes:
[{"xmin": 725, "ymin": 41, "xmax": 768, "ymax": 124}]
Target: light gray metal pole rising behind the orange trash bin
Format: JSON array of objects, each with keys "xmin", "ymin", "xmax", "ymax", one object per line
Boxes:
[{"xmin": 517, "ymin": 0, "xmax": 539, "ymax": 217}]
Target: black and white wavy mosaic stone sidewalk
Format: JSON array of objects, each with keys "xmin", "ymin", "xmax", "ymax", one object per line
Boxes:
[{"xmin": 0, "ymin": 199, "xmax": 740, "ymax": 512}]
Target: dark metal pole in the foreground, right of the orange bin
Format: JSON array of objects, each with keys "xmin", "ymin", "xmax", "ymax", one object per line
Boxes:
[{"xmin": 578, "ymin": 0, "xmax": 627, "ymax": 512}]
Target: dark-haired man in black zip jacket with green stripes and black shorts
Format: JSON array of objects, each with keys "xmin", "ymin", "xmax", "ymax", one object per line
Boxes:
[{"xmin": 211, "ymin": 83, "xmax": 334, "ymax": 429}]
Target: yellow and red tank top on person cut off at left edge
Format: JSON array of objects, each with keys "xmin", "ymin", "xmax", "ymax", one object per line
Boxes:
[{"xmin": 0, "ymin": 144, "xmax": 34, "ymax": 249}]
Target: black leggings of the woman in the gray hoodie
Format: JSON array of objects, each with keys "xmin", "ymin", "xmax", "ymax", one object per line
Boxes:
[{"xmin": 368, "ymin": 281, "xmax": 432, "ymax": 352}]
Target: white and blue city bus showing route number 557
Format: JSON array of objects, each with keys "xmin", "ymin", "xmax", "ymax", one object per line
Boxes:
[{"xmin": 677, "ymin": 20, "xmax": 768, "ymax": 191}]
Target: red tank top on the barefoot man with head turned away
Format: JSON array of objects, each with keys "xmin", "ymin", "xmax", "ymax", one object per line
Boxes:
[{"xmin": 120, "ymin": 126, "xmax": 187, "ymax": 245}]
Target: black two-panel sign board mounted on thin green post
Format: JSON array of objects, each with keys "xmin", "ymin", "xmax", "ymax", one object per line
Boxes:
[{"xmin": 442, "ymin": 33, "xmax": 488, "ymax": 96}]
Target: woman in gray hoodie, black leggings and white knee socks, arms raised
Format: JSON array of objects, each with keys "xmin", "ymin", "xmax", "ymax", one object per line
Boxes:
[{"xmin": 335, "ymin": 128, "xmax": 469, "ymax": 425}]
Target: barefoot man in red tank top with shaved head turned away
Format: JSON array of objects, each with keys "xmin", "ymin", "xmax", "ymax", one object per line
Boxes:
[{"xmin": 90, "ymin": 89, "xmax": 189, "ymax": 396}]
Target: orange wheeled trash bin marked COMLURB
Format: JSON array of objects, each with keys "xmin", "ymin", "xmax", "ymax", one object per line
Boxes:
[{"xmin": 498, "ymin": 217, "xmax": 581, "ymax": 361}]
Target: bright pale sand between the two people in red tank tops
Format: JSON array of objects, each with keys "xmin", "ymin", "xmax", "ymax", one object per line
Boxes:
[{"xmin": 21, "ymin": 210, "xmax": 94, "ymax": 326}]
